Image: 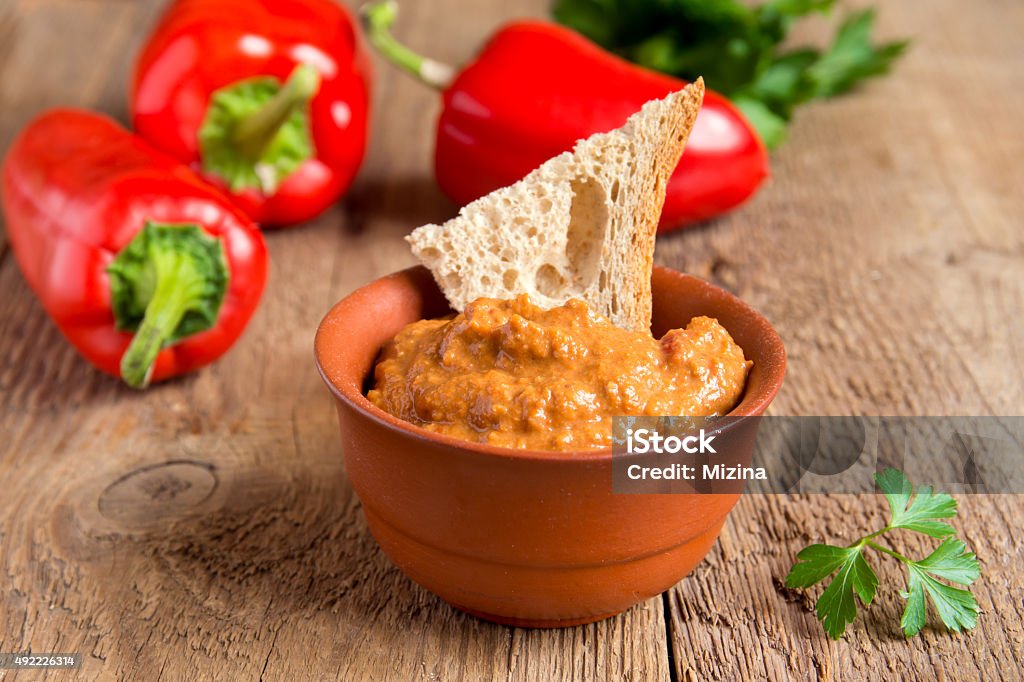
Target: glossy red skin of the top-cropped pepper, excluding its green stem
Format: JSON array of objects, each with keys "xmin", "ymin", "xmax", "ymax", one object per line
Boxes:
[{"xmin": 131, "ymin": 0, "xmax": 371, "ymax": 226}]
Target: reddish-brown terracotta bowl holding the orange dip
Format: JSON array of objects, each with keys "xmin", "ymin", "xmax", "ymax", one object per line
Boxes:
[{"xmin": 315, "ymin": 267, "xmax": 785, "ymax": 627}]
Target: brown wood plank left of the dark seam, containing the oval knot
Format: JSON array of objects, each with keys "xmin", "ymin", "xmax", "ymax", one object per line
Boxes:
[{"xmin": 0, "ymin": 2, "xmax": 668, "ymax": 680}]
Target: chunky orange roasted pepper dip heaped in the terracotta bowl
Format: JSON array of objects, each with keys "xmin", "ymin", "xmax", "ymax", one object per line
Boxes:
[{"xmin": 368, "ymin": 295, "xmax": 752, "ymax": 450}]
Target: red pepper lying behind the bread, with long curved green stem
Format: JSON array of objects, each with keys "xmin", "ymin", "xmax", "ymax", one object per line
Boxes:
[{"xmin": 364, "ymin": 2, "xmax": 768, "ymax": 231}]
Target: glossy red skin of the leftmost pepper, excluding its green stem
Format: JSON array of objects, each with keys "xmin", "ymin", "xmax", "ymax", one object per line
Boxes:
[{"xmin": 2, "ymin": 110, "xmax": 267, "ymax": 381}]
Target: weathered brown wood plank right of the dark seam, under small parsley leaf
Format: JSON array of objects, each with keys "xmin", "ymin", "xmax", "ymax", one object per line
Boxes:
[{"xmin": 658, "ymin": 2, "xmax": 1024, "ymax": 680}]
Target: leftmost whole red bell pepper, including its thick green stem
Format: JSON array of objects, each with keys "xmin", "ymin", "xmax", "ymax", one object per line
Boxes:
[{"xmin": 2, "ymin": 110, "xmax": 267, "ymax": 387}]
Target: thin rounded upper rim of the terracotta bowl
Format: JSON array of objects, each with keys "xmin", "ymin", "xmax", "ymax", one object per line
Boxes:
[{"xmin": 313, "ymin": 265, "xmax": 785, "ymax": 463}]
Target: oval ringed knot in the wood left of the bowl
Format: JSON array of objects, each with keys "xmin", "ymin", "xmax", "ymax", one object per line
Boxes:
[{"xmin": 99, "ymin": 460, "xmax": 217, "ymax": 527}]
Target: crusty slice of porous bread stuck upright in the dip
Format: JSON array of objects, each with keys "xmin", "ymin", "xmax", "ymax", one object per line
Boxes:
[{"xmin": 407, "ymin": 79, "xmax": 703, "ymax": 331}]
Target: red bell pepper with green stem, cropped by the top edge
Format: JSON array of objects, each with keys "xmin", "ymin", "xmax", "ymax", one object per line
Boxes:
[{"xmin": 131, "ymin": 0, "xmax": 370, "ymax": 226}]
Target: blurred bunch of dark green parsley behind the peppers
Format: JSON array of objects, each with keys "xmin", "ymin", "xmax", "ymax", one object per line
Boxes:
[{"xmin": 552, "ymin": 0, "xmax": 907, "ymax": 148}]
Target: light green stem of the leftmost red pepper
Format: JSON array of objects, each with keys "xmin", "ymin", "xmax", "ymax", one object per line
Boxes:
[{"xmin": 121, "ymin": 252, "xmax": 204, "ymax": 388}]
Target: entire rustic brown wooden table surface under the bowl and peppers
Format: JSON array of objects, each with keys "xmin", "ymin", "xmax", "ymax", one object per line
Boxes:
[{"xmin": 0, "ymin": 0, "xmax": 1024, "ymax": 681}]
